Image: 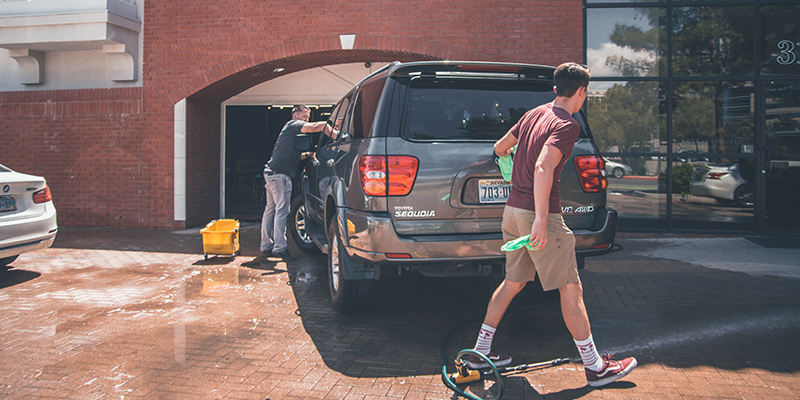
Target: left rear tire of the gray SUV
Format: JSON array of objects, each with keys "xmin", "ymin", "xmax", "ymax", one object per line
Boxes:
[{"xmin": 328, "ymin": 219, "xmax": 372, "ymax": 314}]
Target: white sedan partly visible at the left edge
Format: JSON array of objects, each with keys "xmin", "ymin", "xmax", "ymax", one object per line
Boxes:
[{"xmin": 0, "ymin": 165, "xmax": 58, "ymax": 272}]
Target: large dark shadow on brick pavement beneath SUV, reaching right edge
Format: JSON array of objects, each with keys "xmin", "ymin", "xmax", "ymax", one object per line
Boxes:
[{"xmin": 288, "ymin": 238, "xmax": 800, "ymax": 384}]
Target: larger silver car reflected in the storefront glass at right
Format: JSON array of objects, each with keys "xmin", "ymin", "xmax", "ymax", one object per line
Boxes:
[{"xmin": 689, "ymin": 162, "xmax": 754, "ymax": 207}]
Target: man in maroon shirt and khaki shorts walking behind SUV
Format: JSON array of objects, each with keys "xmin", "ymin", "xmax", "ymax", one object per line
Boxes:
[{"xmin": 468, "ymin": 63, "xmax": 637, "ymax": 387}]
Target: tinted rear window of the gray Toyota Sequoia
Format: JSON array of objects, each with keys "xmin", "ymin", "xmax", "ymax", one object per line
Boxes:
[{"xmin": 402, "ymin": 78, "xmax": 555, "ymax": 141}]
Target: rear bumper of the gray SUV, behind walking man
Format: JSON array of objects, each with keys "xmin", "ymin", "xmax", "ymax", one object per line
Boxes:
[{"xmin": 340, "ymin": 209, "xmax": 617, "ymax": 272}]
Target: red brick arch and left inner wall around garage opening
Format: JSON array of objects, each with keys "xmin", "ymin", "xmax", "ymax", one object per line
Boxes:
[{"xmin": 177, "ymin": 35, "xmax": 492, "ymax": 227}]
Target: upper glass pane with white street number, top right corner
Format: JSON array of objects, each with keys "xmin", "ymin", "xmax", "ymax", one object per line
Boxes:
[{"xmin": 761, "ymin": 4, "xmax": 800, "ymax": 74}]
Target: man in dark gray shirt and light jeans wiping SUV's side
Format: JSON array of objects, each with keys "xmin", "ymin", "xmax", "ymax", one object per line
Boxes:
[{"xmin": 261, "ymin": 105, "xmax": 337, "ymax": 261}]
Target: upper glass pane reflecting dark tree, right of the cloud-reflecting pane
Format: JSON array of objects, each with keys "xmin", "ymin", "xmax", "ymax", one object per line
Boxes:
[{"xmin": 672, "ymin": 6, "xmax": 755, "ymax": 76}]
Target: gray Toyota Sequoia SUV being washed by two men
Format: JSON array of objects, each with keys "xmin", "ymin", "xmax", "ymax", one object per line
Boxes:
[{"xmin": 290, "ymin": 61, "xmax": 617, "ymax": 312}]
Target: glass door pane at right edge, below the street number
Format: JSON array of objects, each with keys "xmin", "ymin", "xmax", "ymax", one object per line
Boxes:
[{"xmin": 762, "ymin": 80, "xmax": 800, "ymax": 234}]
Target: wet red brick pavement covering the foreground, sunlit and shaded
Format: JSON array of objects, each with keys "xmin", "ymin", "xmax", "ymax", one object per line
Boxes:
[{"xmin": 0, "ymin": 223, "xmax": 800, "ymax": 400}]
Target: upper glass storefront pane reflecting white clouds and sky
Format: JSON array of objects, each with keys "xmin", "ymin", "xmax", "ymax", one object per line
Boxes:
[{"xmin": 586, "ymin": 7, "xmax": 667, "ymax": 77}]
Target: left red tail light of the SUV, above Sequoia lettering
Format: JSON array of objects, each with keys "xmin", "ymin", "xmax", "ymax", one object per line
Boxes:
[{"xmin": 358, "ymin": 156, "xmax": 419, "ymax": 196}]
